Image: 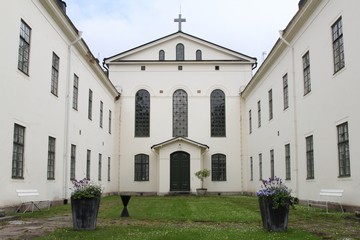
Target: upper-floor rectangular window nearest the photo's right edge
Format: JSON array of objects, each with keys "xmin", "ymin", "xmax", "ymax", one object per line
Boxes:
[{"xmin": 331, "ymin": 17, "xmax": 345, "ymax": 73}]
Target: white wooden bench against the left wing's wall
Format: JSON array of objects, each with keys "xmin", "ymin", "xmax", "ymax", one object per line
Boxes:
[{"xmin": 16, "ymin": 189, "xmax": 50, "ymax": 213}]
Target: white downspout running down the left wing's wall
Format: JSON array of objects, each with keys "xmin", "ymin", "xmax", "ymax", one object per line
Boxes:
[{"xmin": 63, "ymin": 31, "xmax": 82, "ymax": 203}]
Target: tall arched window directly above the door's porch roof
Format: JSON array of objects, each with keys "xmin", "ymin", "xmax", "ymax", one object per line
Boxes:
[{"xmin": 173, "ymin": 89, "xmax": 188, "ymax": 137}]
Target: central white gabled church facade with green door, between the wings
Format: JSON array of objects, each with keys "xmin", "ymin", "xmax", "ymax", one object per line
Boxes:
[{"xmin": 105, "ymin": 31, "xmax": 256, "ymax": 194}]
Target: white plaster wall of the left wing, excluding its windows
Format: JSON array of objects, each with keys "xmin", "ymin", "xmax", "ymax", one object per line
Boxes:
[{"xmin": 0, "ymin": 0, "xmax": 118, "ymax": 207}]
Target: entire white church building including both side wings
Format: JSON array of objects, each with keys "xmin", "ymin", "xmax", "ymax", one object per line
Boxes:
[{"xmin": 0, "ymin": 0, "xmax": 360, "ymax": 210}]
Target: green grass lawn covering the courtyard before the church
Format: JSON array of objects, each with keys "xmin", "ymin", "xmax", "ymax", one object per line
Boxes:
[{"xmin": 27, "ymin": 196, "xmax": 360, "ymax": 240}]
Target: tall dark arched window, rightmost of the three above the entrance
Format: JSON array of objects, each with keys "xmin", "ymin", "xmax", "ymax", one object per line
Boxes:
[{"xmin": 210, "ymin": 89, "xmax": 226, "ymax": 137}]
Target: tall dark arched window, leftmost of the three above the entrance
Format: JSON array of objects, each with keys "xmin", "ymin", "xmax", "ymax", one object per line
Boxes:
[{"xmin": 135, "ymin": 89, "xmax": 150, "ymax": 137}]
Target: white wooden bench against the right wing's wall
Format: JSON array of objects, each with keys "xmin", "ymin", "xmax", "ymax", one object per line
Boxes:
[{"xmin": 308, "ymin": 189, "xmax": 344, "ymax": 213}]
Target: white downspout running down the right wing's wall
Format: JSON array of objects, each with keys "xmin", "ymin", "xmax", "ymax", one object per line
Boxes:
[{"xmin": 279, "ymin": 30, "xmax": 300, "ymax": 197}]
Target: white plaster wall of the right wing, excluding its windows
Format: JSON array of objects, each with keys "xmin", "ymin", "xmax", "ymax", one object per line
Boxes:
[{"xmin": 244, "ymin": 1, "xmax": 360, "ymax": 205}]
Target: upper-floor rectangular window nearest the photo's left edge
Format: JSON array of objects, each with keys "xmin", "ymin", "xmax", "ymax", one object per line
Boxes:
[{"xmin": 18, "ymin": 20, "xmax": 31, "ymax": 75}]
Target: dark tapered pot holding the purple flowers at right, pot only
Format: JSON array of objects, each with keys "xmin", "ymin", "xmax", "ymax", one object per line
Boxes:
[{"xmin": 259, "ymin": 197, "xmax": 289, "ymax": 232}]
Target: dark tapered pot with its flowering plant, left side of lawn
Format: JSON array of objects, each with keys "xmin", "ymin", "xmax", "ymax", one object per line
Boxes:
[{"xmin": 71, "ymin": 178, "xmax": 102, "ymax": 230}]
